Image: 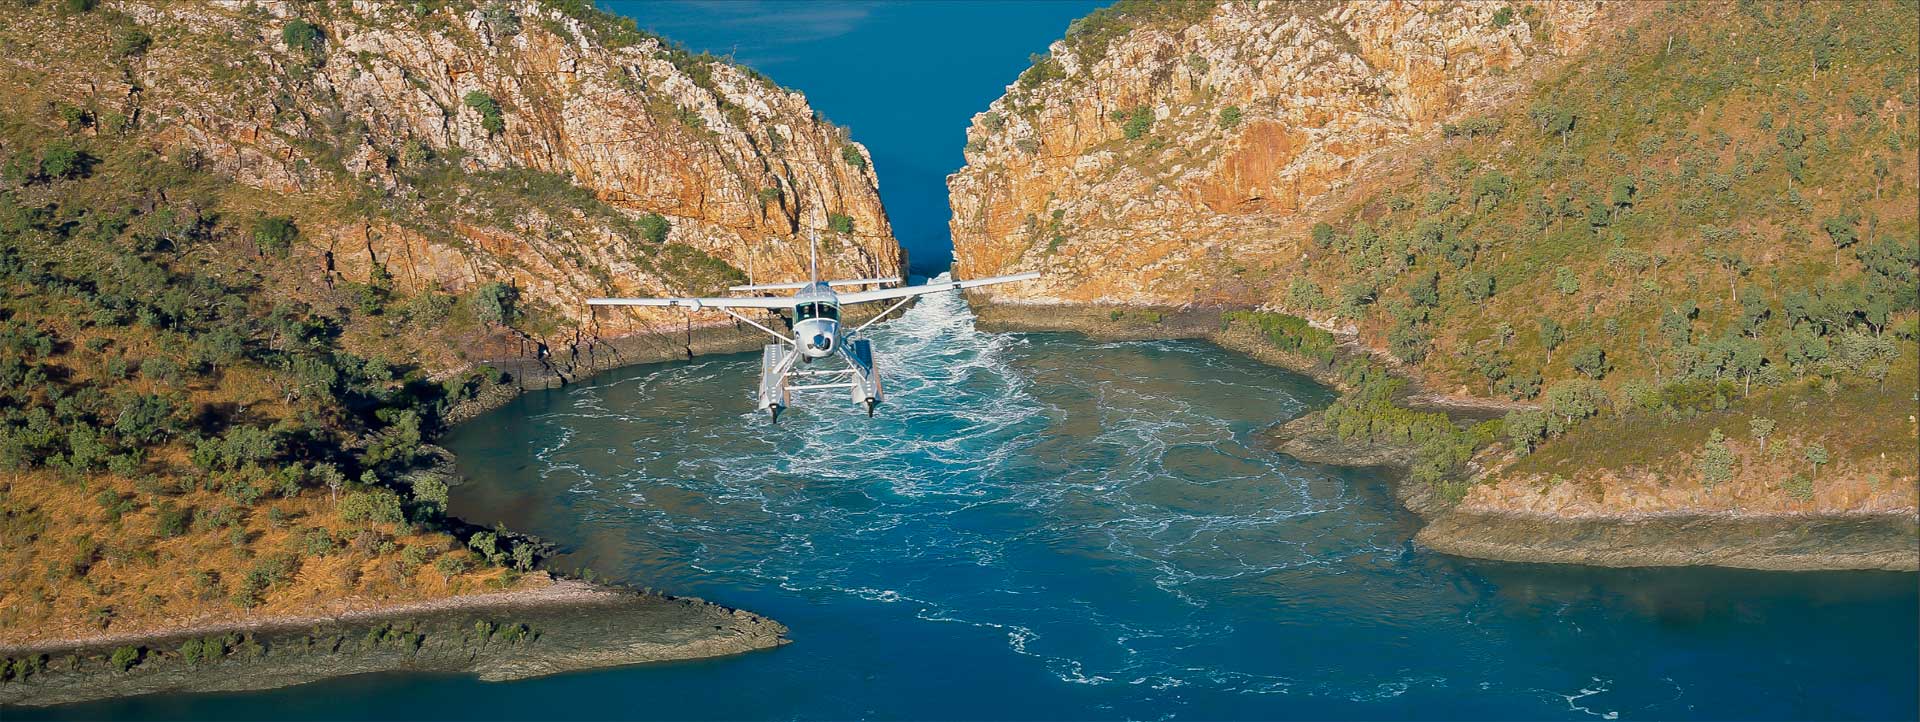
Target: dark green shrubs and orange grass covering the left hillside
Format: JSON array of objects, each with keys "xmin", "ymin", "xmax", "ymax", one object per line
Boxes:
[{"xmin": 0, "ymin": 117, "xmax": 549, "ymax": 630}]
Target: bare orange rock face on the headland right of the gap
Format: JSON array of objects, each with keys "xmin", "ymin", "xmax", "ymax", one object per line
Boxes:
[{"xmin": 947, "ymin": 0, "xmax": 1619, "ymax": 305}]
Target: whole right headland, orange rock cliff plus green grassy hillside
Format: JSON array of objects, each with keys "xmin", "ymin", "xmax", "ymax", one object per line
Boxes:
[{"xmin": 948, "ymin": 2, "xmax": 1920, "ymax": 556}]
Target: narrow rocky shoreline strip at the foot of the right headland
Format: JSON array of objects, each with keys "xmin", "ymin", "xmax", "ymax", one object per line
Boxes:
[{"xmin": 973, "ymin": 300, "xmax": 1920, "ymax": 570}]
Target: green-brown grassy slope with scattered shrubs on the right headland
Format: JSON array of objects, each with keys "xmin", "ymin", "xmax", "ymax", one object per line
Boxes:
[{"xmin": 1284, "ymin": 2, "xmax": 1920, "ymax": 505}]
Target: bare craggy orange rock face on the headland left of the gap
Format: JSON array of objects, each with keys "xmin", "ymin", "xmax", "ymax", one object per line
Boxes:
[{"xmin": 0, "ymin": 0, "xmax": 904, "ymax": 336}]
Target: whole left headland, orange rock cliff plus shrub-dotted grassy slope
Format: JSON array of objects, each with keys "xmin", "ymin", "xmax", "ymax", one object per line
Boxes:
[{"xmin": 0, "ymin": 0, "xmax": 887, "ymax": 649}]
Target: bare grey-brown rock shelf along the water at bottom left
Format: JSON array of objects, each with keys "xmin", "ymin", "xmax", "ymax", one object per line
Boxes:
[{"xmin": 0, "ymin": 580, "xmax": 787, "ymax": 707}]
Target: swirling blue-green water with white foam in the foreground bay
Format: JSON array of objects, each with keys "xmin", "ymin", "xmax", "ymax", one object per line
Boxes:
[{"xmin": 37, "ymin": 289, "xmax": 1920, "ymax": 720}]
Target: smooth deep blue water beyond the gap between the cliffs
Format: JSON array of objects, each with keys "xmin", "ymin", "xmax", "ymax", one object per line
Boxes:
[{"xmin": 601, "ymin": 0, "xmax": 1106, "ymax": 275}]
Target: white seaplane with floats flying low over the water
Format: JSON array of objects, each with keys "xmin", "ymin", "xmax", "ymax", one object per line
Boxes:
[{"xmin": 588, "ymin": 232, "xmax": 1041, "ymax": 422}]
